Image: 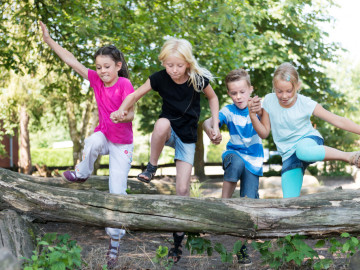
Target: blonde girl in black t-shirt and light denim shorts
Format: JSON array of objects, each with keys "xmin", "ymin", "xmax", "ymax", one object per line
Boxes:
[{"xmin": 112, "ymin": 38, "xmax": 220, "ymax": 262}]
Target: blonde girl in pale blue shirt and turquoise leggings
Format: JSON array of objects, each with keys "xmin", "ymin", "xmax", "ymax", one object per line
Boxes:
[{"xmin": 249, "ymin": 63, "xmax": 360, "ymax": 198}]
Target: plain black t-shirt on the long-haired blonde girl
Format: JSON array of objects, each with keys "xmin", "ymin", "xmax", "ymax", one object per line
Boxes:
[{"xmin": 149, "ymin": 69, "xmax": 209, "ymax": 143}]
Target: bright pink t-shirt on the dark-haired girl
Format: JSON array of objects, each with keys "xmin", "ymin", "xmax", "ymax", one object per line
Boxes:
[{"xmin": 88, "ymin": 69, "xmax": 134, "ymax": 144}]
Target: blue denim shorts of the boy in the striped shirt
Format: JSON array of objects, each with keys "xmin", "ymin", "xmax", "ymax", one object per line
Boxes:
[{"xmin": 223, "ymin": 153, "xmax": 259, "ymax": 199}]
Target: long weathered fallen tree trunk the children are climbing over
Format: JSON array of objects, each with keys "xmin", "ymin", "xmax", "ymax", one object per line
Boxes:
[{"xmin": 0, "ymin": 169, "xmax": 360, "ymax": 238}]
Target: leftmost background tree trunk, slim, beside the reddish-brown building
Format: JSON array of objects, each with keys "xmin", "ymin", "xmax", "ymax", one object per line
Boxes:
[{"xmin": 19, "ymin": 105, "xmax": 32, "ymax": 174}]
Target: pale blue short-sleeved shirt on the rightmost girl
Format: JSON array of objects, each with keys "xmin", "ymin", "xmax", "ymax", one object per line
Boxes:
[{"xmin": 262, "ymin": 93, "xmax": 322, "ymax": 161}]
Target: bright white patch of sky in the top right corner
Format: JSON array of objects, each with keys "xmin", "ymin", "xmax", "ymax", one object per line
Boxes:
[{"xmin": 326, "ymin": 0, "xmax": 360, "ymax": 61}]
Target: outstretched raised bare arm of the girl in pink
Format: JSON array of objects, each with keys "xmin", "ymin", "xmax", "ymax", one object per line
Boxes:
[{"xmin": 40, "ymin": 21, "xmax": 88, "ymax": 79}]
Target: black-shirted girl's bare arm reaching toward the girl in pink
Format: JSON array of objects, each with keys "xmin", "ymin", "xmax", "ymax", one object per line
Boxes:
[{"xmin": 110, "ymin": 79, "xmax": 151, "ymax": 123}]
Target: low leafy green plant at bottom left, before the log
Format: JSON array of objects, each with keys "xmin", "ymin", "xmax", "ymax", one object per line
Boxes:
[{"xmin": 23, "ymin": 233, "xmax": 85, "ymax": 270}]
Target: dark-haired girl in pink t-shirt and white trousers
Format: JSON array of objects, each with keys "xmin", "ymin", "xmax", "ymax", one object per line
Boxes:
[{"xmin": 40, "ymin": 22, "xmax": 134, "ymax": 267}]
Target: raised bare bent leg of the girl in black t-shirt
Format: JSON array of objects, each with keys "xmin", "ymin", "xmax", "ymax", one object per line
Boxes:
[{"xmin": 150, "ymin": 118, "xmax": 171, "ymax": 166}]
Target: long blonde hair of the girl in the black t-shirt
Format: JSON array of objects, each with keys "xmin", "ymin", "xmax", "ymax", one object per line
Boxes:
[{"xmin": 159, "ymin": 38, "xmax": 214, "ymax": 92}]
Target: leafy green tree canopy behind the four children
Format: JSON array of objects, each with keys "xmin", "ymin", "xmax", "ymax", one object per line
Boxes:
[{"xmin": 0, "ymin": 0, "xmax": 344, "ymax": 175}]
